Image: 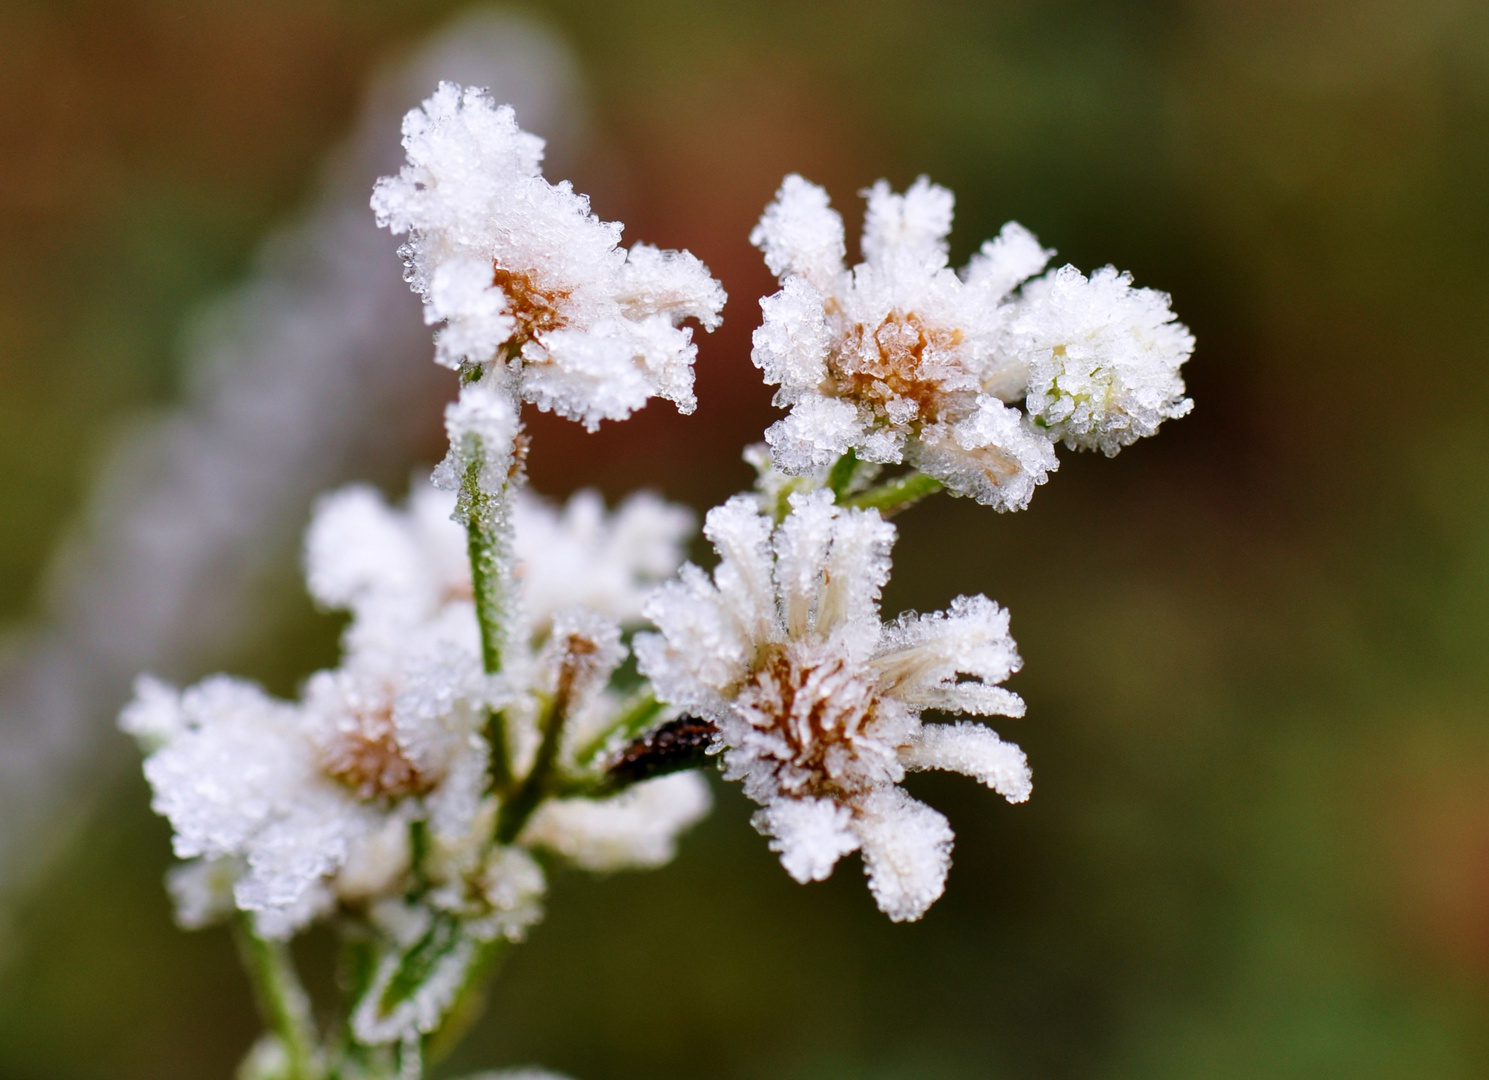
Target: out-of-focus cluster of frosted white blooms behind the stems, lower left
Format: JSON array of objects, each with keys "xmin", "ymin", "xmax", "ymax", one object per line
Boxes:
[{"xmin": 121, "ymin": 484, "xmax": 710, "ymax": 1041}]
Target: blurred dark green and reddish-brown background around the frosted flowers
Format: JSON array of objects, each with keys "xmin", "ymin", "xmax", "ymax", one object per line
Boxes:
[{"xmin": 0, "ymin": 0, "xmax": 1489, "ymax": 1080}]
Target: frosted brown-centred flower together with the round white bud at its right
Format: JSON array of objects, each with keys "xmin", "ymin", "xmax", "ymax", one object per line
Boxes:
[{"xmin": 750, "ymin": 176, "xmax": 1194, "ymax": 509}]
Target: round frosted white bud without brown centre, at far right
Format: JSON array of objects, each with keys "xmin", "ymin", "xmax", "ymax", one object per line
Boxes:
[{"xmin": 1011, "ymin": 267, "xmax": 1194, "ymax": 457}]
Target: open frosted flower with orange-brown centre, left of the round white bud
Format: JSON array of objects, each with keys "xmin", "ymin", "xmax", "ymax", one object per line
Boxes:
[{"xmin": 750, "ymin": 176, "xmax": 1057, "ymax": 509}]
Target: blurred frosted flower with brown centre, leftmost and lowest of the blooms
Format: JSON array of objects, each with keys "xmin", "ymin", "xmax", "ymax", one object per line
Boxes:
[{"xmin": 121, "ymin": 622, "xmax": 488, "ymax": 937}]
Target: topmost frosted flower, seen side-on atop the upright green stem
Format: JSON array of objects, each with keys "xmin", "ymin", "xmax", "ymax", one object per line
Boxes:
[{"xmin": 372, "ymin": 82, "xmax": 725, "ymax": 431}]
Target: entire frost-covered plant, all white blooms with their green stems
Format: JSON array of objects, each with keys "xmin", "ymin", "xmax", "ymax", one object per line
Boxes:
[{"xmin": 122, "ymin": 83, "xmax": 1193, "ymax": 1080}]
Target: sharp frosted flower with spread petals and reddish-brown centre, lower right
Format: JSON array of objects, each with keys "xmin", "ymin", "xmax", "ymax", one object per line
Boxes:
[{"xmin": 636, "ymin": 492, "xmax": 1030, "ymax": 921}]
